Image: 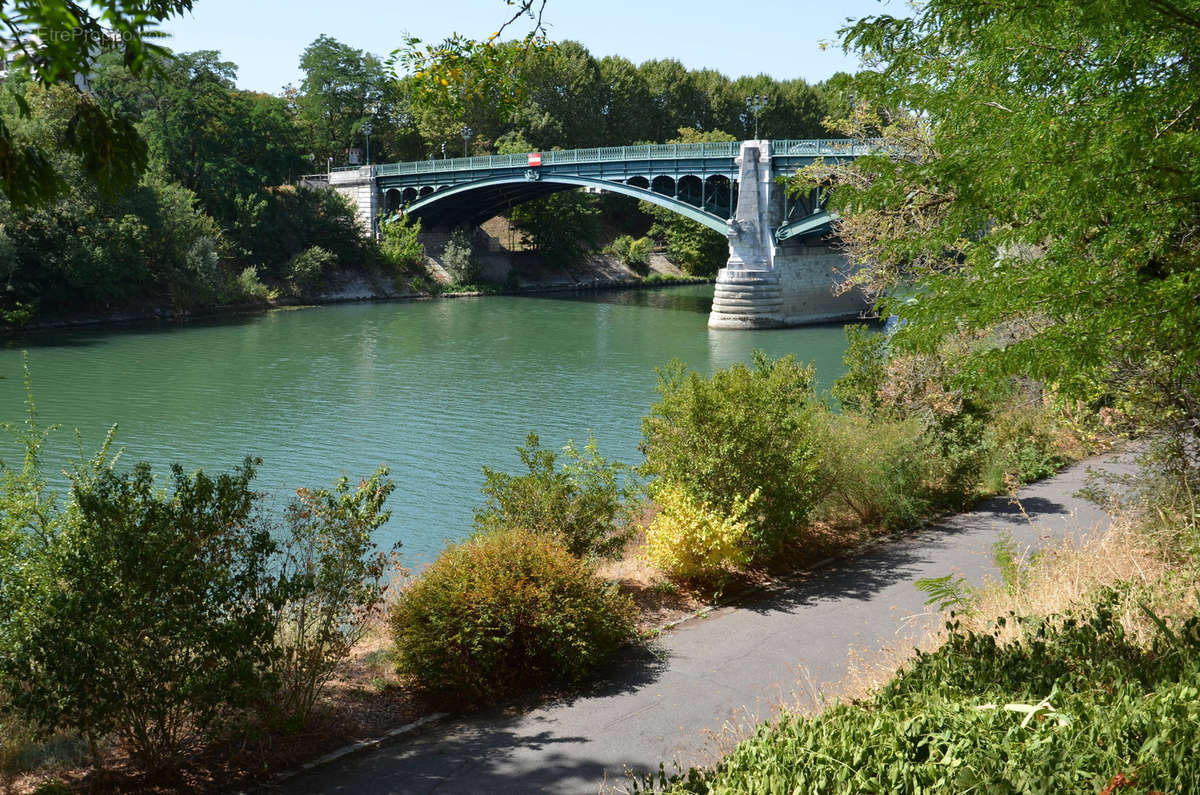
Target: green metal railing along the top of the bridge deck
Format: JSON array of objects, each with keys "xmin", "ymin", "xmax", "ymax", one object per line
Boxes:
[{"xmin": 369, "ymin": 138, "xmax": 882, "ymax": 177}]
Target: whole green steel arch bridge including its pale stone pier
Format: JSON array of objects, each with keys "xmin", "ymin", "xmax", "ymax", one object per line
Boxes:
[{"xmin": 328, "ymin": 138, "xmax": 880, "ymax": 328}]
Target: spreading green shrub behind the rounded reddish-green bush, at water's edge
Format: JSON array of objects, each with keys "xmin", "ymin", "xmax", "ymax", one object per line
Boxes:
[{"xmin": 475, "ymin": 434, "xmax": 634, "ymax": 557}]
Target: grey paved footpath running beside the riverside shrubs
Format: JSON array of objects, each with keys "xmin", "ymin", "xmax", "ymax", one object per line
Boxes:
[{"xmin": 284, "ymin": 459, "xmax": 1124, "ymax": 794}]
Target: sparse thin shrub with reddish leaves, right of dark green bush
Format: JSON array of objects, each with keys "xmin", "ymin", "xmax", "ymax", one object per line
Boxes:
[{"xmin": 275, "ymin": 467, "xmax": 398, "ymax": 725}]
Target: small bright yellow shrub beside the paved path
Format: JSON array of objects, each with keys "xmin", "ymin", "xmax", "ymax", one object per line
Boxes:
[{"xmin": 646, "ymin": 485, "xmax": 758, "ymax": 584}]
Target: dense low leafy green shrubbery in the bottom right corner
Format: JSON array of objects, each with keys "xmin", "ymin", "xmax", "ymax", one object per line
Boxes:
[{"xmin": 644, "ymin": 597, "xmax": 1200, "ymax": 793}]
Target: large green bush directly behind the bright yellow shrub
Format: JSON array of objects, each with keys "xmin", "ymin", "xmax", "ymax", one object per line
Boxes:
[{"xmin": 642, "ymin": 351, "xmax": 823, "ymax": 561}]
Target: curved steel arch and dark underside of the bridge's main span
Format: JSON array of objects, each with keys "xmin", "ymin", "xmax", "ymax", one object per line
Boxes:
[{"xmin": 407, "ymin": 174, "xmax": 728, "ymax": 234}]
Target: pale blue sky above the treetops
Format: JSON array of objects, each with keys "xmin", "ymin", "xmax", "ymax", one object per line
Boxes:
[{"xmin": 154, "ymin": 0, "xmax": 907, "ymax": 94}]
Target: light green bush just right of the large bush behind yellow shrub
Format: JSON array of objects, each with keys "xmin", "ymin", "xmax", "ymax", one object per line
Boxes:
[{"xmin": 820, "ymin": 414, "xmax": 935, "ymax": 530}]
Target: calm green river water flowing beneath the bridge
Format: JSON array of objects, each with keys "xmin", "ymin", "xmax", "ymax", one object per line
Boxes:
[{"xmin": 0, "ymin": 286, "xmax": 859, "ymax": 566}]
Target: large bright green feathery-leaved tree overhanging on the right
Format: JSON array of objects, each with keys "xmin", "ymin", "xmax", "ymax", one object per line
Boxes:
[{"xmin": 815, "ymin": 0, "xmax": 1200, "ymax": 485}]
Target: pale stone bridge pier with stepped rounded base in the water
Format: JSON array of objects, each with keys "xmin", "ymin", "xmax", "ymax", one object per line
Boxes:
[{"xmin": 708, "ymin": 141, "xmax": 868, "ymax": 329}]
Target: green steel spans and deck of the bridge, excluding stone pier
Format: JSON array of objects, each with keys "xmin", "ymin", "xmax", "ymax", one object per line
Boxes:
[{"xmin": 357, "ymin": 138, "xmax": 878, "ymax": 241}]
